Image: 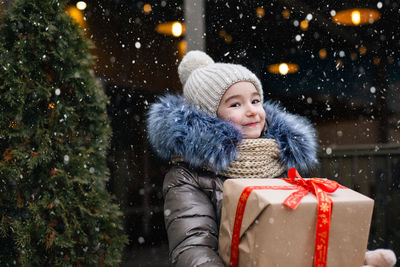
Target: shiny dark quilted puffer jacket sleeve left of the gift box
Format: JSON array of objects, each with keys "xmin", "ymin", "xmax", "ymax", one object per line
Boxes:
[{"xmin": 163, "ymin": 166, "xmax": 224, "ymax": 267}]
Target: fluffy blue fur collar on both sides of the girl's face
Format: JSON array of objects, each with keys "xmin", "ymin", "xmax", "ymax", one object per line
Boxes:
[{"xmin": 147, "ymin": 94, "xmax": 318, "ymax": 175}]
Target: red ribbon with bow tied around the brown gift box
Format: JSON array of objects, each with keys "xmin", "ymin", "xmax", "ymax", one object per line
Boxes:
[{"xmin": 230, "ymin": 168, "xmax": 341, "ymax": 267}]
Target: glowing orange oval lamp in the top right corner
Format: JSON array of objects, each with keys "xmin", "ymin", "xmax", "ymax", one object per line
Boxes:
[{"xmin": 332, "ymin": 8, "xmax": 381, "ymax": 26}]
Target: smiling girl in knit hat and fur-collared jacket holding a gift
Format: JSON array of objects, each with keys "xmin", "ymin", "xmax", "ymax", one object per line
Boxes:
[{"xmin": 147, "ymin": 51, "xmax": 394, "ymax": 267}]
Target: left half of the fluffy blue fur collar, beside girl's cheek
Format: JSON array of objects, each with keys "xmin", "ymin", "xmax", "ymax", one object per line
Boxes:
[{"xmin": 147, "ymin": 95, "xmax": 241, "ymax": 171}]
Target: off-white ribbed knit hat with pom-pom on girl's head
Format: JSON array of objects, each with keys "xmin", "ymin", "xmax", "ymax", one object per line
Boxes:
[{"xmin": 178, "ymin": 50, "xmax": 263, "ymax": 117}]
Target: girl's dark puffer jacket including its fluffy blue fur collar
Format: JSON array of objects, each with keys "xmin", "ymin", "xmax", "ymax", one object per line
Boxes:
[{"xmin": 147, "ymin": 95, "xmax": 317, "ymax": 267}]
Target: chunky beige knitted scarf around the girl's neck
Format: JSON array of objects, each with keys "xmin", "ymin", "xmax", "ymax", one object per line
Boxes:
[{"xmin": 172, "ymin": 138, "xmax": 286, "ymax": 178}]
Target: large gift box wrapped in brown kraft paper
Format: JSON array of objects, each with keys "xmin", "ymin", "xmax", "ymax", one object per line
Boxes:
[{"xmin": 219, "ymin": 179, "xmax": 374, "ymax": 267}]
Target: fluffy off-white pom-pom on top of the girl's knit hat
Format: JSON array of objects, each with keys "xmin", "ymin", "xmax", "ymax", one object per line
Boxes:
[{"xmin": 178, "ymin": 50, "xmax": 214, "ymax": 85}]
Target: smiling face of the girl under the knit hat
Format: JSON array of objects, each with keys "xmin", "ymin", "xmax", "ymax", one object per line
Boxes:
[{"xmin": 217, "ymin": 81, "xmax": 265, "ymax": 138}]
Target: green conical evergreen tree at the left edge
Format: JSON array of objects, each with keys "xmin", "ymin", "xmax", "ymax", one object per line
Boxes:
[{"xmin": 0, "ymin": 0, "xmax": 127, "ymax": 266}]
